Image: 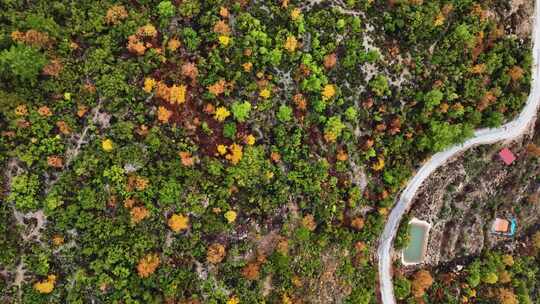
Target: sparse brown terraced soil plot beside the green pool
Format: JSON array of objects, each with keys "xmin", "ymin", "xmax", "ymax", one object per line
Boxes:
[{"xmin": 408, "ymin": 120, "xmax": 540, "ymax": 270}]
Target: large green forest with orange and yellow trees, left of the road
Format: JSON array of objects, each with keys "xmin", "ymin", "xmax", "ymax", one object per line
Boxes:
[{"xmin": 0, "ymin": 0, "xmax": 531, "ymax": 304}]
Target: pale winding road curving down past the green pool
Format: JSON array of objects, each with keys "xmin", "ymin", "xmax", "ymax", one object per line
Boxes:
[{"xmin": 377, "ymin": 0, "xmax": 540, "ymax": 304}]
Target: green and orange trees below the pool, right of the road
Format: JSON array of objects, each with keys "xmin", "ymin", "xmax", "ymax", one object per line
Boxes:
[{"xmin": 395, "ymin": 236, "xmax": 540, "ymax": 304}]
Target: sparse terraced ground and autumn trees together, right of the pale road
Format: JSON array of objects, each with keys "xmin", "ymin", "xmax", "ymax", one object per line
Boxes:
[{"xmin": 394, "ymin": 113, "xmax": 540, "ymax": 304}]
